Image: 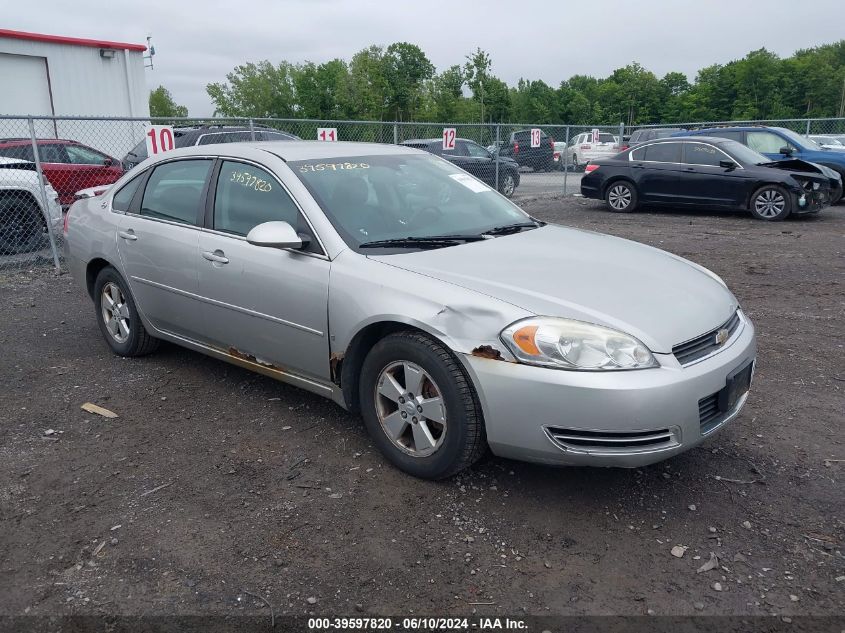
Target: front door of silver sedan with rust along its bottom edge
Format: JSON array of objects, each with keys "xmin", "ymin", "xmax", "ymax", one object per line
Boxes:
[{"xmin": 196, "ymin": 160, "xmax": 331, "ymax": 382}]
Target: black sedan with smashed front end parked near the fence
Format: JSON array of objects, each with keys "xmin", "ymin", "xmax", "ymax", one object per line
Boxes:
[{"xmin": 581, "ymin": 136, "xmax": 830, "ymax": 220}]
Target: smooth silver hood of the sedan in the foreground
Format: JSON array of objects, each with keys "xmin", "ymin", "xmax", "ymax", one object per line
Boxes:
[{"xmin": 370, "ymin": 226, "xmax": 738, "ymax": 353}]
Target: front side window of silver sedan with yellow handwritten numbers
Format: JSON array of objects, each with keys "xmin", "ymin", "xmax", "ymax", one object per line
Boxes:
[{"xmin": 214, "ymin": 161, "xmax": 304, "ymax": 235}]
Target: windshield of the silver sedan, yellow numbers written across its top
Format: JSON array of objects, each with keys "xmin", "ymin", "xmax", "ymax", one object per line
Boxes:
[{"xmin": 288, "ymin": 154, "xmax": 531, "ymax": 249}]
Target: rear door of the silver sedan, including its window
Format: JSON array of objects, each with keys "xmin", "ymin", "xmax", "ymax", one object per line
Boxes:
[{"xmin": 115, "ymin": 158, "xmax": 213, "ymax": 341}]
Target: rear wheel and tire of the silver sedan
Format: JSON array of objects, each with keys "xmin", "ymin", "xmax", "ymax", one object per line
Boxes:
[{"xmin": 94, "ymin": 266, "xmax": 160, "ymax": 356}]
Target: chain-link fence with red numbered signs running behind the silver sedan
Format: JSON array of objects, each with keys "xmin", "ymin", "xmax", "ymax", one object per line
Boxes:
[{"xmin": 0, "ymin": 116, "xmax": 845, "ymax": 269}]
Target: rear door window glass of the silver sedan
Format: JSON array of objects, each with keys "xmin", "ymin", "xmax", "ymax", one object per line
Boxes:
[{"xmin": 141, "ymin": 159, "xmax": 211, "ymax": 224}]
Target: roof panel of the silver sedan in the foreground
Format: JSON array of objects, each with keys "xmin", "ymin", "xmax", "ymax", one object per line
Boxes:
[{"xmin": 161, "ymin": 141, "xmax": 418, "ymax": 161}]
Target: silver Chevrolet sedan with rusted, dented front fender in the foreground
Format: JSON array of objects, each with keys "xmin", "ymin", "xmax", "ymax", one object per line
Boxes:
[{"xmin": 65, "ymin": 141, "xmax": 755, "ymax": 478}]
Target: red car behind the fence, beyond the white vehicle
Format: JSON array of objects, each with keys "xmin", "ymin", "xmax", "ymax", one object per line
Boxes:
[{"xmin": 0, "ymin": 138, "xmax": 123, "ymax": 207}]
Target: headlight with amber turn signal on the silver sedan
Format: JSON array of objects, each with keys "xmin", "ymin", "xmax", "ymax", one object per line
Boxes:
[{"xmin": 501, "ymin": 317, "xmax": 658, "ymax": 371}]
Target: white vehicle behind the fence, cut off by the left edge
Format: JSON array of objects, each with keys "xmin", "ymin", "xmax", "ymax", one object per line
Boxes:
[{"xmin": 0, "ymin": 157, "xmax": 62, "ymax": 255}]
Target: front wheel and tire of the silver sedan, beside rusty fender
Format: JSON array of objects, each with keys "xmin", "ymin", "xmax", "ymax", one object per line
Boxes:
[{"xmin": 358, "ymin": 332, "xmax": 487, "ymax": 479}]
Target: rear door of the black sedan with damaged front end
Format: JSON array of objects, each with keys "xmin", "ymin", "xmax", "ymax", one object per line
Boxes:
[{"xmin": 630, "ymin": 142, "xmax": 682, "ymax": 203}]
